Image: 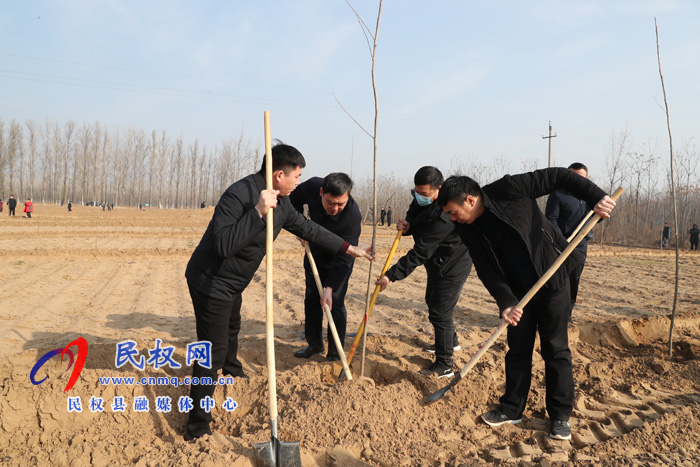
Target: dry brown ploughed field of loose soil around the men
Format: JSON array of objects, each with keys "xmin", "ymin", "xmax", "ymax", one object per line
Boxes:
[{"xmin": 0, "ymin": 204, "xmax": 700, "ymax": 467}]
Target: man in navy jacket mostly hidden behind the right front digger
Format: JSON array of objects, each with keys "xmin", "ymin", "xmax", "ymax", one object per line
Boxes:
[{"xmin": 544, "ymin": 162, "xmax": 593, "ymax": 322}]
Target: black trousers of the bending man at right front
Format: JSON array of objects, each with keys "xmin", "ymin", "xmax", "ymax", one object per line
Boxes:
[{"xmin": 500, "ymin": 284, "xmax": 574, "ymax": 420}]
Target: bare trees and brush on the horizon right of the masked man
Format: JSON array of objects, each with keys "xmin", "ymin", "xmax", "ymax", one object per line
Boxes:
[{"xmin": 443, "ymin": 134, "xmax": 700, "ymax": 248}]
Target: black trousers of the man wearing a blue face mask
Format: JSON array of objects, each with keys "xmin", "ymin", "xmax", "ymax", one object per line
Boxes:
[{"xmin": 425, "ymin": 270, "xmax": 469, "ymax": 366}]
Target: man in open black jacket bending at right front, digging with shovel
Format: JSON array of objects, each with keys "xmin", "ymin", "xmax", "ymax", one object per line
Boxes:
[{"xmin": 438, "ymin": 168, "xmax": 615, "ymax": 439}]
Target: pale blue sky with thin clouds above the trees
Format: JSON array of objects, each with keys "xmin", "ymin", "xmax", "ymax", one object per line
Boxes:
[{"xmin": 0, "ymin": 0, "xmax": 700, "ymax": 185}]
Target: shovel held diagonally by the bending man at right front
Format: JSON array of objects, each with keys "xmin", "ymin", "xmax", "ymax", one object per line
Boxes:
[{"xmin": 424, "ymin": 187, "xmax": 625, "ymax": 405}]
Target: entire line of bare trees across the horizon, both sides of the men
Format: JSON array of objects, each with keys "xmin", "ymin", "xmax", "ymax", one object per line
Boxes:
[{"xmin": 0, "ymin": 118, "xmax": 700, "ymax": 247}]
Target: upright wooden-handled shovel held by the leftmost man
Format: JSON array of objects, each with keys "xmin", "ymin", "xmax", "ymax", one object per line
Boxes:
[{"xmin": 254, "ymin": 111, "xmax": 301, "ymax": 467}]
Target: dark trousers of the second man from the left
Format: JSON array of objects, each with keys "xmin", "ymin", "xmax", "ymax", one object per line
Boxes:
[{"xmin": 304, "ymin": 267, "xmax": 349, "ymax": 356}]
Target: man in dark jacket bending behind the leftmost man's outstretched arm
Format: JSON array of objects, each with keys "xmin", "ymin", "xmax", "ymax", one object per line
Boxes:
[{"xmin": 289, "ymin": 173, "xmax": 362, "ymax": 361}]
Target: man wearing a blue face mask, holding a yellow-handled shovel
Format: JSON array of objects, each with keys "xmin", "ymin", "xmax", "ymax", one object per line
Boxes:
[{"xmin": 376, "ymin": 166, "xmax": 472, "ymax": 378}]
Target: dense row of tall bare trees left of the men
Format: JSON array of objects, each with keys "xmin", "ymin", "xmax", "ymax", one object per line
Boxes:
[{"xmin": 0, "ymin": 119, "xmax": 260, "ymax": 208}]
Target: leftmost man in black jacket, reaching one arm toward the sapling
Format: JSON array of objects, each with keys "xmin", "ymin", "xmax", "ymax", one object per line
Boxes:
[{"xmin": 184, "ymin": 144, "xmax": 371, "ymax": 441}]
